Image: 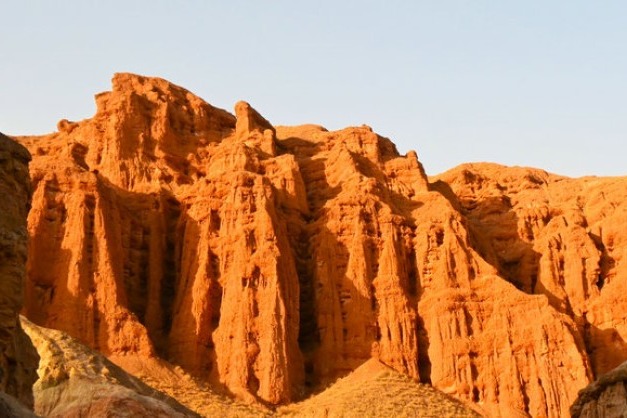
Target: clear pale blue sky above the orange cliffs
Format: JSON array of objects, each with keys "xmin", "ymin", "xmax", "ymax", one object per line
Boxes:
[{"xmin": 0, "ymin": 0, "xmax": 627, "ymax": 176}]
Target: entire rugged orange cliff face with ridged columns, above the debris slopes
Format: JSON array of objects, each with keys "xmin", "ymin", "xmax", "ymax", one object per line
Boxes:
[{"xmin": 14, "ymin": 74, "xmax": 627, "ymax": 417}]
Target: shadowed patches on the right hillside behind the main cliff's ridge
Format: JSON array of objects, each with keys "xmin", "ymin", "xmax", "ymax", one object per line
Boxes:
[{"xmin": 430, "ymin": 180, "xmax": 627, "ymax": 386}]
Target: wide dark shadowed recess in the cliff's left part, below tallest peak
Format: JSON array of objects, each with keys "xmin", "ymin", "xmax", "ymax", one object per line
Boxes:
[{"xmin": 92, "ymin": 175, "xmax": 181, "ymax": 352}]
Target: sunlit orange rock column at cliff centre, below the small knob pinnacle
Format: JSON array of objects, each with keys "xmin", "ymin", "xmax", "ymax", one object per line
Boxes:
[{"xmin": 214, "ymin": 173, "xmax": 303, "ymax": 403}]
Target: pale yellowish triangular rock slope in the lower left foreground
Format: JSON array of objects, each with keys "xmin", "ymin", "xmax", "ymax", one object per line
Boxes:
[{"xmin": 22, "ymin": 319, "xmax": 198, "ymax": 418}]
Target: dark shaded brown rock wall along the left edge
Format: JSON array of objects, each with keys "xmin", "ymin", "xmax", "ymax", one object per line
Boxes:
[{"xmin": 0, "ymin": 134, "xmax": 37, "ymax": 407}]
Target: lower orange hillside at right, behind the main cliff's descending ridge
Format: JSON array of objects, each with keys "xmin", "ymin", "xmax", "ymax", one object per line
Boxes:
[{"xmin": 436, "ymin": 164, "xmax": 627, "ymax": 376}]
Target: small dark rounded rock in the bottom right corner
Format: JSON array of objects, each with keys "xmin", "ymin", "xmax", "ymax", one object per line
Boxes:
[{"xmin": 570, "ymin": 362, "xmax": 627, "ymax": 418}]
